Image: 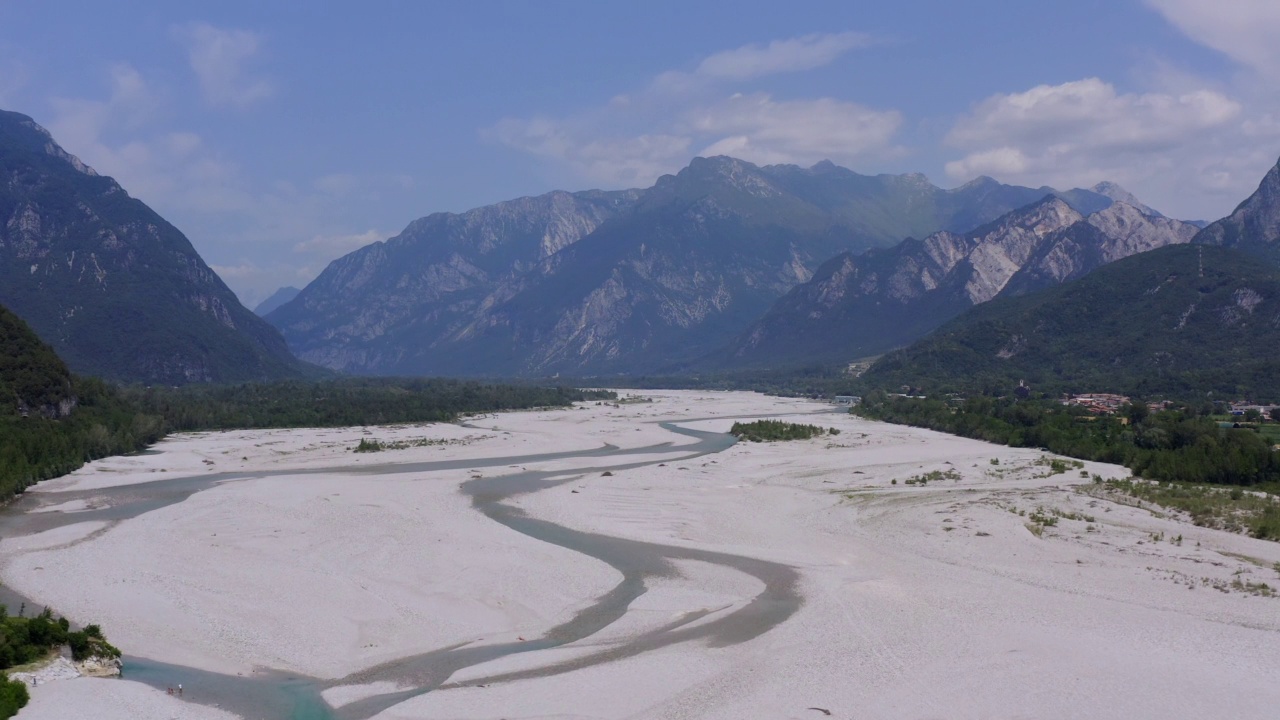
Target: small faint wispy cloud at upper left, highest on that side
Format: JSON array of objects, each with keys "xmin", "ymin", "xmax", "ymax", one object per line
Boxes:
[{"xmin": 173, "ymin": 23, "xmax": 275, "ymax": 108}]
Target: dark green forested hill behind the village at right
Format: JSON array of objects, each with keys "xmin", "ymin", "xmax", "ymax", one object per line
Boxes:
[{"xmin": 863, "ymin": 245, "xmax": 1280, "ymax": 400}]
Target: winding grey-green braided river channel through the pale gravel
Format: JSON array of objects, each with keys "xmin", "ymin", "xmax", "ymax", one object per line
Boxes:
[{"xmin": 0, "ymin": 423, "xmax": 803, "ymax": 720}]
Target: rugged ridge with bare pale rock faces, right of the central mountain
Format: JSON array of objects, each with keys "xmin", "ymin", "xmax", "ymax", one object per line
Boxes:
[{"xmin": 705, "ymin": 193, "xmax": 1196, "ymax": 368}]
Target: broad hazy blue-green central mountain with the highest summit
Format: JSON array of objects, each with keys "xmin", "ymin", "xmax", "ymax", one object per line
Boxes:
[{"xmin": 269, "ymin": 158, "xmax": 1112, "ymax": 375}]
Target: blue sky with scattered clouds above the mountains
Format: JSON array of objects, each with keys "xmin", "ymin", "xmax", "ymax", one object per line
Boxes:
[{"xmin": 0, "ymin": 0, "xmax": 1280, "ymax": 307}]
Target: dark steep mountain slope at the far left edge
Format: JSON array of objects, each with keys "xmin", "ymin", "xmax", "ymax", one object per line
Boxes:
[{"xmin": 0, "ymin": 111, "xmax": 300, "ymax": 383}]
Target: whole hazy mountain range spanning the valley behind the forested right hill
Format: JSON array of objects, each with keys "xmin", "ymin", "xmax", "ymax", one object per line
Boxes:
[{"xmin": 0, "ymin": 98, "xmax": 1280, "ymax": 384}]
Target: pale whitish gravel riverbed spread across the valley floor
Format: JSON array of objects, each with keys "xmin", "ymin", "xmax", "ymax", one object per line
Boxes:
[{"xmin": 0, "ymin": 391, "xmax": 1280, "ymax": 719}]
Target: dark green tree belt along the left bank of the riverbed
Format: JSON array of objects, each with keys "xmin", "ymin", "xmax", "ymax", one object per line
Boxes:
[{"xmin": 0, "ymin": 297, "xmax": 617, "ymax": 502}]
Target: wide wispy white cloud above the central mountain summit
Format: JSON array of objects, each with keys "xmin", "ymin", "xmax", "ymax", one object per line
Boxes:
[{"xmin": 484, "ymin": 32, "xmax": 902, "ymax": 186}]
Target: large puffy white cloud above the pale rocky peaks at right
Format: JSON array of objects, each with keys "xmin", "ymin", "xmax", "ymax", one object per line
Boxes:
[{"xmin": 946, "ymin": 78, "xmax": 1280, "ymax": 219}]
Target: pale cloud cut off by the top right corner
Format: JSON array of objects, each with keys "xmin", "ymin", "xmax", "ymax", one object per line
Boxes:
[{"xmin": 1147, "ymin": 0, "xmax": 1280, "ymax": 78}]
